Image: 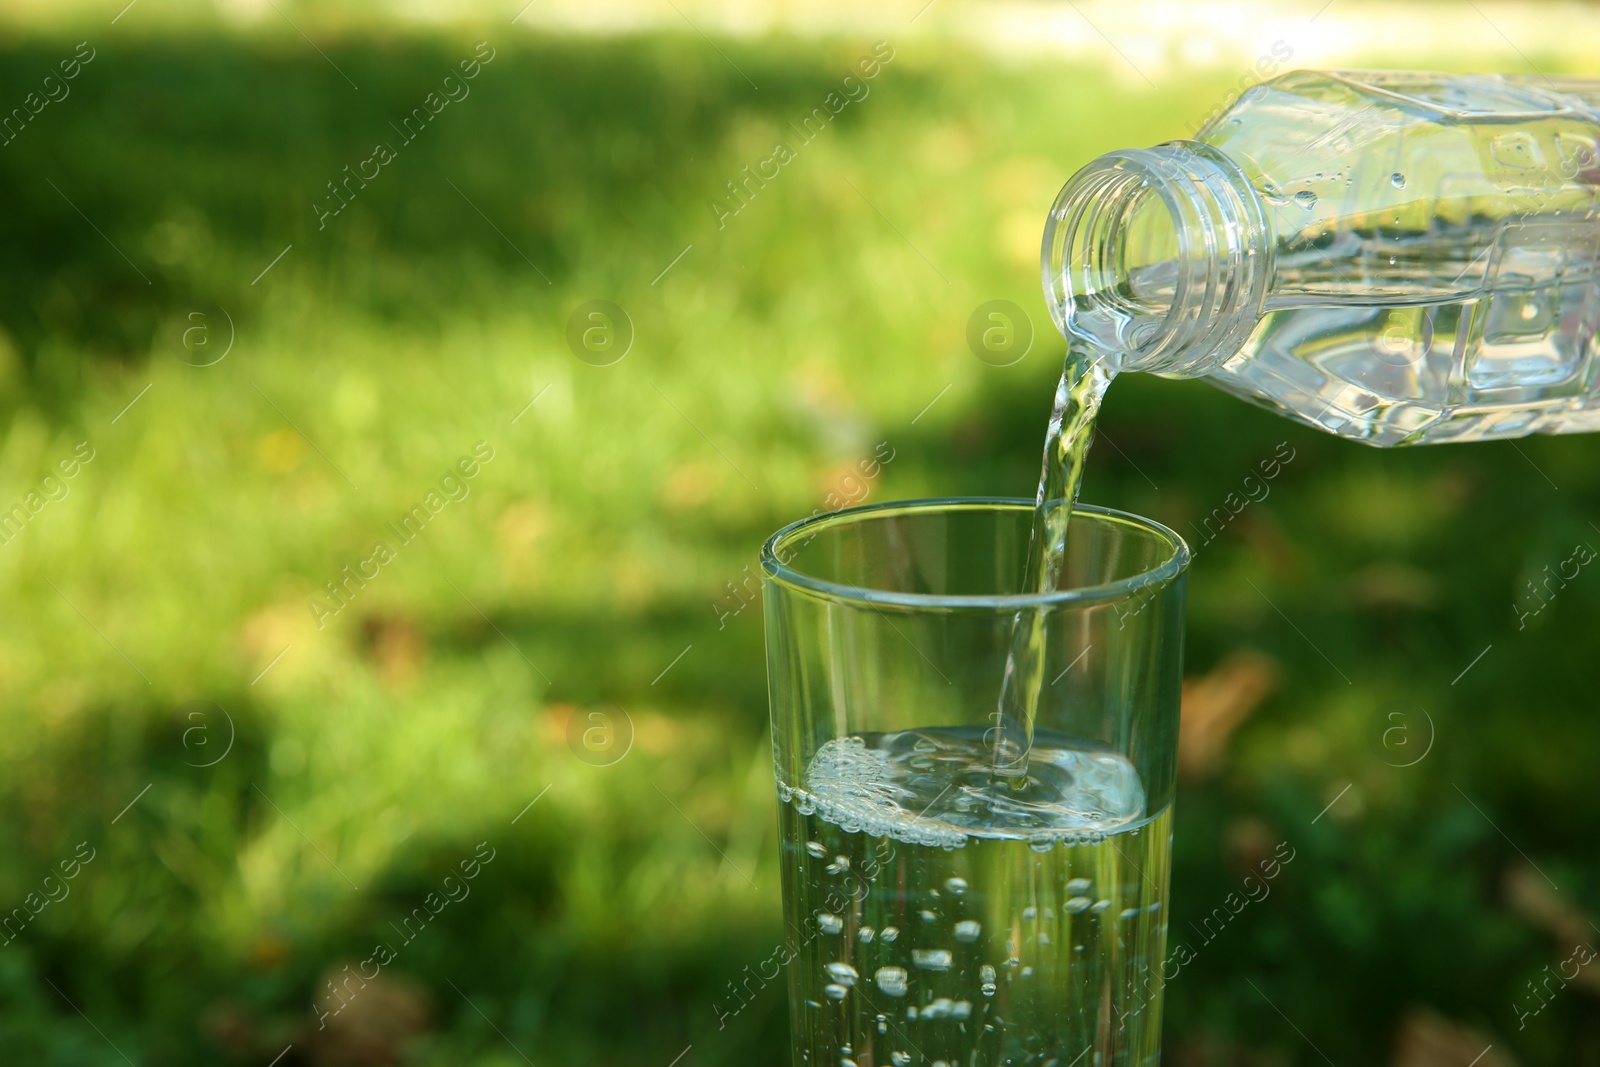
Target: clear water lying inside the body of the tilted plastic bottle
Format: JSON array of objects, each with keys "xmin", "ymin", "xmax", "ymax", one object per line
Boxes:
[{"xmin": 1213, "ymin": 212, "xmax": 1600, "ymax": 445}]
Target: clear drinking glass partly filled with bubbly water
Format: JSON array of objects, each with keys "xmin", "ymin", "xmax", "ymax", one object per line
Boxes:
[{"xmin": 762, "ymin": 499, "xmax": 1189, "ymax": 1067}]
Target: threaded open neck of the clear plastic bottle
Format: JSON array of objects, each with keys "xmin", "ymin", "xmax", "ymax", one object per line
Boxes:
[{"xmin": 1042, "ymin": 141, "xmax": 1272, "ymax": 378}]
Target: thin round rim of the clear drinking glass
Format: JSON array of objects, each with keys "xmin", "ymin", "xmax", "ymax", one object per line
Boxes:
[{"xmin": 762, "ymin": 496, "xmax": 1192, "ymax": 611}]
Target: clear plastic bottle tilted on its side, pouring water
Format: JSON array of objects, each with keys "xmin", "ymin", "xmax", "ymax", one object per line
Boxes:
[{"xmin": 1043, "ymin": 72, "xmax": 1600, "ymax": 445}]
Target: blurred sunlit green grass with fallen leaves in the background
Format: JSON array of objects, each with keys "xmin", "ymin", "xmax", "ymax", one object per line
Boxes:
[{"xmin": 0, "ymin": 18, "xmax": 1600, "ymax": 1067}]
